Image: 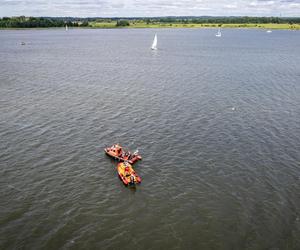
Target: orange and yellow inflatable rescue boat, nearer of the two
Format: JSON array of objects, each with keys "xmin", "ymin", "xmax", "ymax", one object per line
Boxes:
[{"xmin": 117, "ymin": 161, "xmax": 142, "ymax": 186}]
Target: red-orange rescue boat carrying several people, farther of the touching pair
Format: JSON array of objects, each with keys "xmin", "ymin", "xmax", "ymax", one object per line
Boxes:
[{"xmin": 104, "ymin": 144, "xmax": 142, "ymax": 164}]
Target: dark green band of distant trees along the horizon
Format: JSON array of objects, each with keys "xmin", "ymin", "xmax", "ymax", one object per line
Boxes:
[{"xmin": 0, "ymin": 16, "xmax": 300, "ymax": 28}]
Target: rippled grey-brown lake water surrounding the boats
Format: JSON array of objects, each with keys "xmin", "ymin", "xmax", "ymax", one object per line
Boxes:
[{"xmin": 0, "ymin": 29, "xmax": 300, "ymax": 249}]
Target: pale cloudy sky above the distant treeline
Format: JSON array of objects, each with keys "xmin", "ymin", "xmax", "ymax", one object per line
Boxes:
[{"xmin": 0, "ymin": 0, "xmax": 300, "ymax": 17}]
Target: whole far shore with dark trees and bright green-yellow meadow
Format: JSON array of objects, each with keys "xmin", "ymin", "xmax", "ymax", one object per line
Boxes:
[{"xmin": 0, "ymin": 16, "xmax": 300, "ymax": 30}]
